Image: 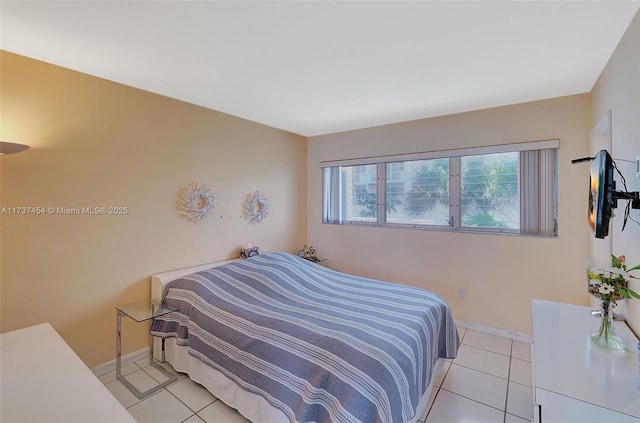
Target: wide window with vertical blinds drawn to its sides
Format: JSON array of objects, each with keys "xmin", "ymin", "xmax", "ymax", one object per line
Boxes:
[{"xmin": 323, "ymin": 140, "xmax": 559, "ymax": 236}]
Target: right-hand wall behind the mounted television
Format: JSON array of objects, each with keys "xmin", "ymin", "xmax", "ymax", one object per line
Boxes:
[{"xmin": 590, "ymin": 8, "xmax": 640, "ymax": 335}]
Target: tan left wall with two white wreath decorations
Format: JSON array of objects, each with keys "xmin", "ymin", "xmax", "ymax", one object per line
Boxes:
[{"xmin": 0, "ymin": 52, "xmax": 307, "ymax": 366}]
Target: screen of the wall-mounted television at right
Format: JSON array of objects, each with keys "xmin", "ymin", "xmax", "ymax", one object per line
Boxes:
[{"xmin": 587, "ymin": 150, "xmax": 614, "ymax": 238}]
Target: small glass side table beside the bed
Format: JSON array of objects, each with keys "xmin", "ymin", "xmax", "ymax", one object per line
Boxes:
[{"xmin": 116, "ymin": 299, "xmax": 177, "ymax": 399}]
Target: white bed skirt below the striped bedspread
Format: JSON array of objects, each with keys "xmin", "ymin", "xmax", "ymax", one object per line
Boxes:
[{"xmin": 165, "ymin": 338, "xmax": 445, "ymax": 423}]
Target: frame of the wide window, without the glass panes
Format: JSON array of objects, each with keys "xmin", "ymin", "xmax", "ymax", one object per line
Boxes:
[{"xmin": 321, "ymin": 139, "xmax": 560, "ymax": 238}]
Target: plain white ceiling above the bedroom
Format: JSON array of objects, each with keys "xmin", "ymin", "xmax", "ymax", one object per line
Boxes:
[{"xmin": 0, "ymin": 0, "xmax": 640, "ymax": 136}]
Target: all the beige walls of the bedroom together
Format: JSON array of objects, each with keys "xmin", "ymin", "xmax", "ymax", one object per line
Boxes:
[{"xmin": 0, "ymin": 16, "xmax": 640, "ymax": 366}]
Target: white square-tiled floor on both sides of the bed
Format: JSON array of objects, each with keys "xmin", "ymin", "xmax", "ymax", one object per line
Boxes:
[{"xmin": 100, "ymin": 328, "xmax": 533, "ymax": 423}]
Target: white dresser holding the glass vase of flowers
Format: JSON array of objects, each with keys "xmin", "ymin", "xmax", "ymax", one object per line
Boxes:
[{"xmin": 533, "ymin": 300, "xmax": 640, "ymax": 423}]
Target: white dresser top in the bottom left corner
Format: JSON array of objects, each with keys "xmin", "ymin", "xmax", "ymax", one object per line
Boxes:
[{"xmin": 0, "ymin": 323, "xmax": 135, "ymax": 423}]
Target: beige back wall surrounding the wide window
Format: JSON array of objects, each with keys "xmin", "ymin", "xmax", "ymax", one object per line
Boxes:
[{"xmin": 308, "ymin": 94, "xmax": 590, "ymax": 334}]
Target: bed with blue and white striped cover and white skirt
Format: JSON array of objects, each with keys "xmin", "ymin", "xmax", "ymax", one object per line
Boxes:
[{"xmin": 151, "ymin": 253, "xmax": 459, "ymax": 423}]
